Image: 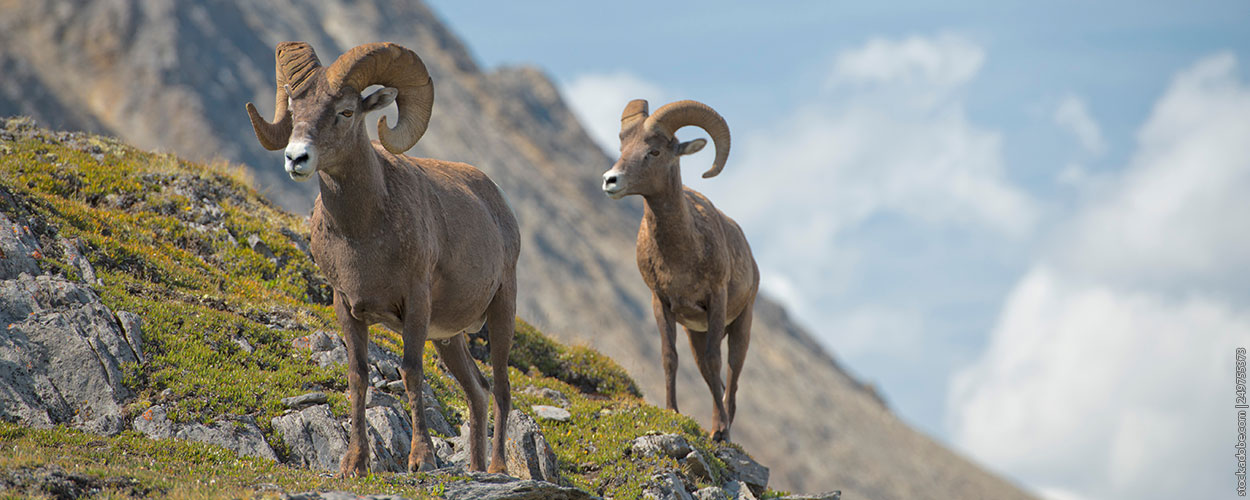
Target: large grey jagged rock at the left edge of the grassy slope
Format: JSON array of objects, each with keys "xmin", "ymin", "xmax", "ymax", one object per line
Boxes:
[{"xmin": 0, "ymin": 261, "xmax": 139, "ymax": 435}]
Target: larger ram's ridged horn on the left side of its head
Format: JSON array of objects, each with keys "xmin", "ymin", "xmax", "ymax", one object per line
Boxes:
[{"xmin": 248, "ymin": 41, "xmax": 321, "ymax": 151}]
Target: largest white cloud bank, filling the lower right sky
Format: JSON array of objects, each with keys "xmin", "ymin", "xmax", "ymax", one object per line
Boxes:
[{"xmin": 948, "ymin": 54, "xmax": 1250, "ymax": 499}]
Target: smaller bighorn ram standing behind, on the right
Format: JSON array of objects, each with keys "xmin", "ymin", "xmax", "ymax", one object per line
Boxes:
[{"xmin": 604, "ymin": 99, "xmax": 760, "ymax": 441}]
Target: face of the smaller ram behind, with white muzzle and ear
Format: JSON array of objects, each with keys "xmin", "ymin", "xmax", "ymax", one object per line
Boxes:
[{"xmin": 603, "ymin": 126, "xmax": 708, "ymax": 200}]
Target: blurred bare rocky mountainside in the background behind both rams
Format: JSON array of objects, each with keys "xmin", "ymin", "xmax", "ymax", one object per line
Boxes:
[{"xmin": 0, "ymin": 0, "xmax": 1028, "ymax": 499}]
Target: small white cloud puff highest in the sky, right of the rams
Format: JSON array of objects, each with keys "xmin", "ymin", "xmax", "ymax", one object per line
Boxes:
[{"xmin": 830, "ymin": 34, "xmax": 985, "ymax": 88}]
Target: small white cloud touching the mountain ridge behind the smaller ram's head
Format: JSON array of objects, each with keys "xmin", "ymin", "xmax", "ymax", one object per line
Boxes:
[{"xmin": 564, "ymin": 71, "xmax": 671, "ymax": 151}]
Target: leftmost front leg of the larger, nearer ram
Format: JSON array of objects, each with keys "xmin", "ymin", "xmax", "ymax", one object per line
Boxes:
[{"xmin": 334, "ymin": 291, "xmax": 369, "ymax": 478}]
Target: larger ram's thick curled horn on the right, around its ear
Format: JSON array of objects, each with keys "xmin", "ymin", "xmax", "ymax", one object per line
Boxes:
[{"xmin": 326, "ymin": 43, "xmax": 434, "ymax": 155}]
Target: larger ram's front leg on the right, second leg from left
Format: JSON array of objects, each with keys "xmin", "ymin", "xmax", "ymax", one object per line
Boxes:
[{"xmin": 401, "ymin": 291, "xmax": 438, "ymax": 471}]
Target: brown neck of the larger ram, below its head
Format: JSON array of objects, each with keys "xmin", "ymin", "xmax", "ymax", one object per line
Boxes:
[{"xmin": 318, "ymin": 149, "xmax": 388, "ymax": 236}]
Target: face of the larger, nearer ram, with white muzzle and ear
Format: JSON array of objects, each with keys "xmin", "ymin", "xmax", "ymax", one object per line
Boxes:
[{"xmin": 285, "ymin": 86, "xmax": 398, "ymax": 181}]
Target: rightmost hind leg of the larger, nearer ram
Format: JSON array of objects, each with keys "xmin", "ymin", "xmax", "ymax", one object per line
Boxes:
[{"xmin": 486, "ymin": 276, "xmax": 516, "ymax": 473}]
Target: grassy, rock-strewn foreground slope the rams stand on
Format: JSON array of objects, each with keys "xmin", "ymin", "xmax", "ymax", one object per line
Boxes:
[{"xmin": 0, "ymin": 119, "xmax": 810, "ymax": 500}]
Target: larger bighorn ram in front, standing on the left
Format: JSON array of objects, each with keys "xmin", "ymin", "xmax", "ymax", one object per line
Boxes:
[{"xmin": 246, "ymin": 41, "xmax": 520, "ymax": 475}]
